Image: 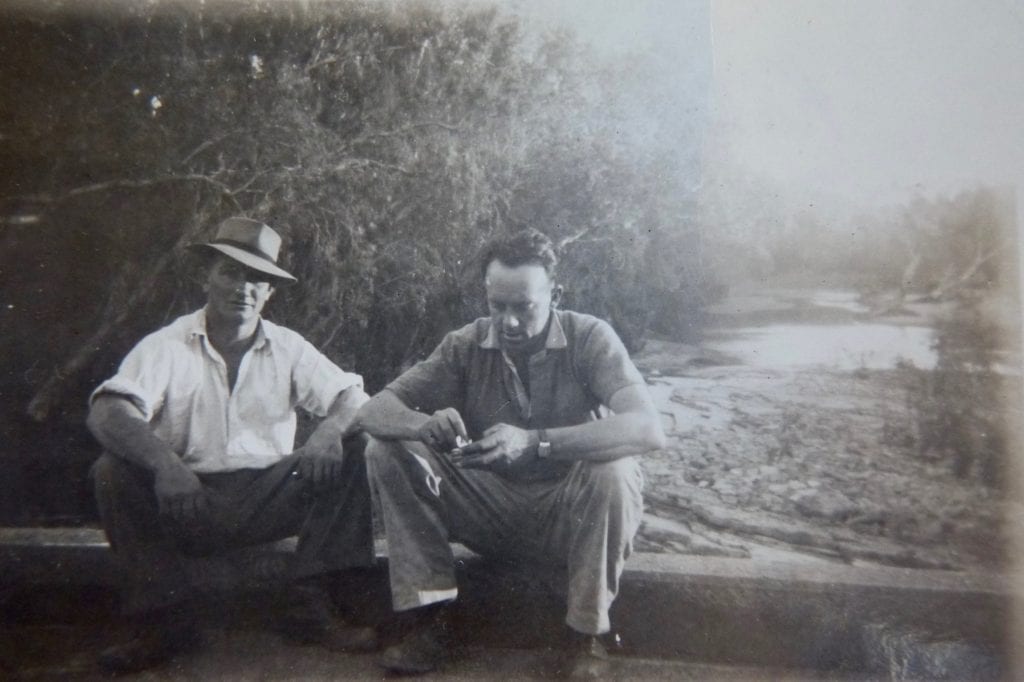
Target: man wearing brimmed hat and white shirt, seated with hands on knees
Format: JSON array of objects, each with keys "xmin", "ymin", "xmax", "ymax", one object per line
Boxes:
[{"xmin": 88, "ymin": 217, "xmax": 376, "ymax": 672}]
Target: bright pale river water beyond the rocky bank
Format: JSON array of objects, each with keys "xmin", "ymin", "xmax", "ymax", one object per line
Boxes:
[{"xmin": 702, "ymin": 290, "xmax": 936, "ymax": 370}]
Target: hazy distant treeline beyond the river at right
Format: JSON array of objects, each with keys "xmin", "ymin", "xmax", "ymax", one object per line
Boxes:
[{"xmin": 701, "ymin": 178, "xmax": 1018, "ymax": 301}]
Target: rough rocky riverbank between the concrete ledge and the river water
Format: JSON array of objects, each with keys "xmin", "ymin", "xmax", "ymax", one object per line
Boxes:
[{"xmin": 635, "ymin": 340, "xmax": 1024, "ymax": 569}]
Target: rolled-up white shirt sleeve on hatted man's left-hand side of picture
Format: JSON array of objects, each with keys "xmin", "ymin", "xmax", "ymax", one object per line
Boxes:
[{"xmin": 89, "ymin": 337, "xmax": 174, "ymax": 421}]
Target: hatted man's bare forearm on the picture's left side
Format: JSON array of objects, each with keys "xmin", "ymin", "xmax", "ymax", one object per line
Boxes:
[{"xmin": 87, "ymin": 395, "xmax": 183, "ymax": 473}]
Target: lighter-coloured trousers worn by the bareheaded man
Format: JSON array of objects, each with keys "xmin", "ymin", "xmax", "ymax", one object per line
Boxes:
[{"xmin": 367, "ymin": 439, "xmax": 643, "ymax": 635}]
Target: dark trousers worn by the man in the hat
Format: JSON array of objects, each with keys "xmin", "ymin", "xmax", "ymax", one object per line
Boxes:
[{"xmin": 92, "ymin": 439, "xmax": 374, "ymax": 613}]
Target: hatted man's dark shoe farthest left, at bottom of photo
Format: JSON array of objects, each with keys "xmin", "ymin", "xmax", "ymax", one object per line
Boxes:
[{"xmin": 97, "ymin": 616, "xmax": 203, "ymax": 675}]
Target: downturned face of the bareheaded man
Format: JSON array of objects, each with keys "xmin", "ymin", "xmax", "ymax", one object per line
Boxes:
[{"xmin": 483, "ymin": 260, "xmax": 558, "ymax": 351}]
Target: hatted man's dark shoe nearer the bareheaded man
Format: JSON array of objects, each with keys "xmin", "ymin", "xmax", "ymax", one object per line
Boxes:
[{"xmin": 275, "ymin": 588, "xmax": 377, "ymax": 651}]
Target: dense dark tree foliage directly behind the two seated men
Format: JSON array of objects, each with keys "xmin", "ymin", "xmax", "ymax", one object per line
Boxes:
[{"xmin": 0, "ymin": 2, "xmax": 713, "ymax": 519}]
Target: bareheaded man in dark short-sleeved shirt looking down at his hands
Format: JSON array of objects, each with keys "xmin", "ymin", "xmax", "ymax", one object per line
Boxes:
[{"xmin": 359, "ymin": 229, "xmax": 665, "ymax": 677}]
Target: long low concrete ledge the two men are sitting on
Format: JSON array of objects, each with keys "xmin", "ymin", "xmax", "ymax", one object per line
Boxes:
[{"xmin": 0, "ymin": 528, "xmax": 1021, "ymax": 679}]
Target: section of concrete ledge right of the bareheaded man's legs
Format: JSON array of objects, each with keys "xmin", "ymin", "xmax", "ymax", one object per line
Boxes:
[{"xmin": 612, "ymin": 555, "xmax": 1020, "ymax": 679}]
